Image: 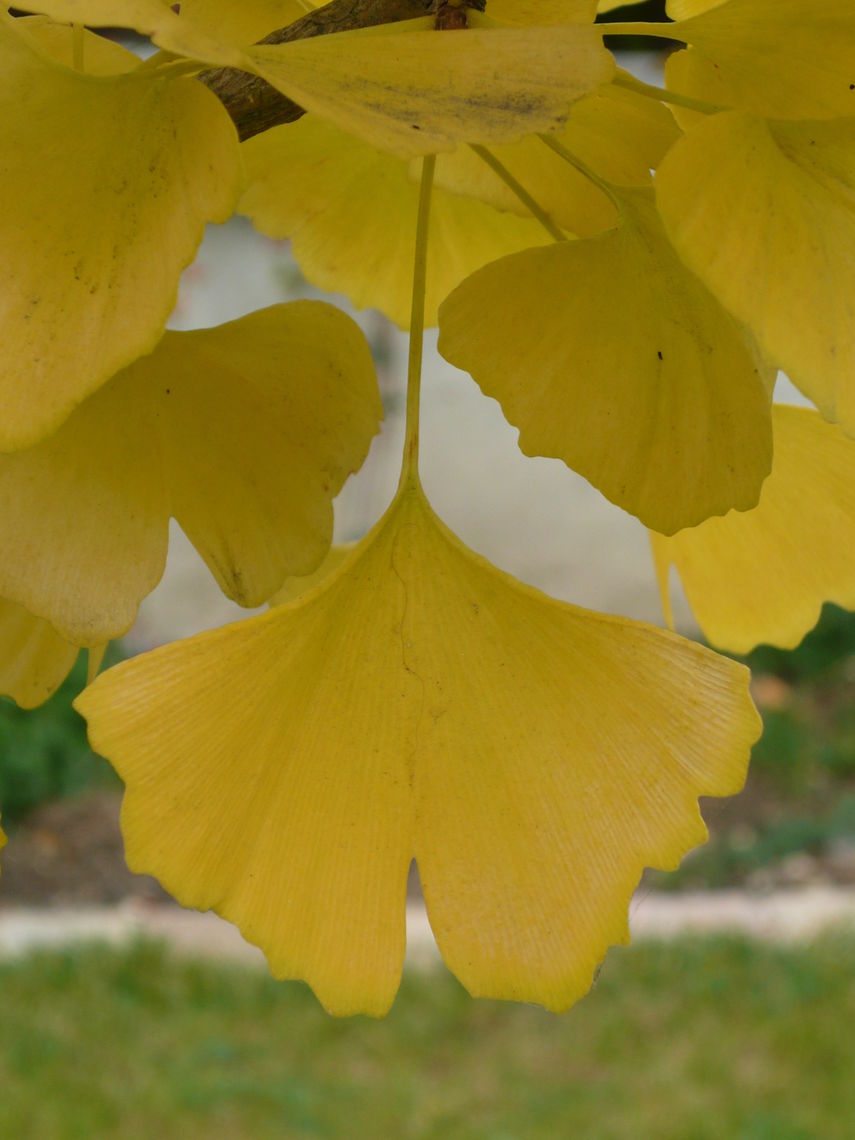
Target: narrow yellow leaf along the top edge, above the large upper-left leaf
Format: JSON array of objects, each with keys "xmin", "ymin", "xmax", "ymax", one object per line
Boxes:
[{"xmin": 16, "ymin": 0, "xmax": 253, "ymax": 67}]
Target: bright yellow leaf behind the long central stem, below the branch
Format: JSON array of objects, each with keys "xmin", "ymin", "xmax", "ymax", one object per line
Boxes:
[{"xmin": 238, "ymin": 115, "xmax": 549, "ymax": 328}]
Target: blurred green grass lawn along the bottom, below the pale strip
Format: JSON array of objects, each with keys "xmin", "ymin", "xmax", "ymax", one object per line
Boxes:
[{"xmin": 0, "ymin": 934, "xmax": 855, "ymax": 1140}]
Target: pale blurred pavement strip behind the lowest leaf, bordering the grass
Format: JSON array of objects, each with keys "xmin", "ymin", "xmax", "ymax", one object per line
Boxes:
[{"xmin": 0, "ymin": 887, "xmax": 855, "ymax": 969}]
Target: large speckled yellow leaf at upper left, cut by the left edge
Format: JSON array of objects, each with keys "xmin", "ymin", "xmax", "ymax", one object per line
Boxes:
[{"xmin": 0, "ymin": 14, "xmax": 238, "ymax": 450}]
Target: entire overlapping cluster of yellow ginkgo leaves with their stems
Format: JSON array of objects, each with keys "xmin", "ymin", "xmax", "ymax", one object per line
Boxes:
[{"xmin": 0, "ymin": 0, "xmax": 855, "ymax": 1013}]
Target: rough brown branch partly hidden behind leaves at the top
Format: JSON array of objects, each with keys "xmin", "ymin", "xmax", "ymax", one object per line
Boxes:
[{"xmin": 200, "ymin": 0, "xmax": 435, "ymax": 139}]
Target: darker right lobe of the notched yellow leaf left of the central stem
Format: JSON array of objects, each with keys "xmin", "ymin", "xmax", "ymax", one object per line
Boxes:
[{"xmin": 157, "ymin": 301, "xmax": 383, "ymax": 605}]
